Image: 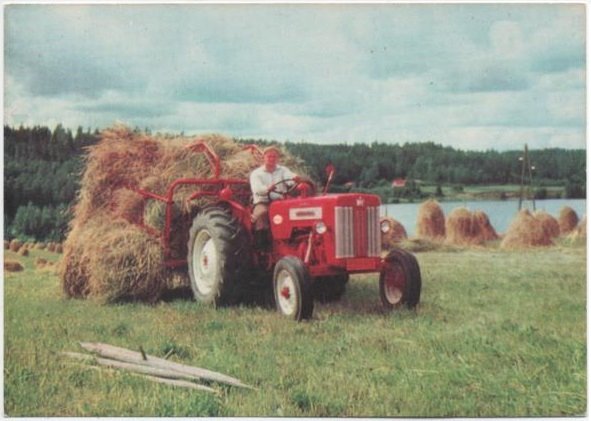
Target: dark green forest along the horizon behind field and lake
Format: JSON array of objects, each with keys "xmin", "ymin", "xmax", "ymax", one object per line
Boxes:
[{"xmin": 4, "ymin": 124, "xmax": 586, "ymax": 241}]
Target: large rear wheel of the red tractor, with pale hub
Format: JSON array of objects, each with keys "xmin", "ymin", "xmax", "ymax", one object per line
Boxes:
[{"xmin": 187, "ymin": 207, "xmax": 250, "ymax": 306}]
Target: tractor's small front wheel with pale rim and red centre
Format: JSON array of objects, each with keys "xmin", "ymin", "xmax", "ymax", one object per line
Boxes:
[{"xmin": 273, "ymin": 256, "xmax": 314, "ymax": 321}]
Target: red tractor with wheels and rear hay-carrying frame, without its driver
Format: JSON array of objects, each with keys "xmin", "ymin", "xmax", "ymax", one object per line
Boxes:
[{"xmin": 134, "ymin": 142, "xmax": 421, "ymax": 321}]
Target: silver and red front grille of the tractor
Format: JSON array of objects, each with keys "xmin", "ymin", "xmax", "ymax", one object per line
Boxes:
[{"xmin": 335, "ymin": 206, "xmax": 381, "ymax": 259}]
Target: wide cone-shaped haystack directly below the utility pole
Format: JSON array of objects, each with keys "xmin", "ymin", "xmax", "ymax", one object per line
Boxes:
[{"xmin": 501, "ymin": 209, "xmax": 552, "ymax": 249}]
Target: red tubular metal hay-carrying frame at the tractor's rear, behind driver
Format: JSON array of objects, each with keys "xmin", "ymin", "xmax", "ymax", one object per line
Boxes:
[{"xmin": 128, "ymin": 141, "xmax": 261, "ymax": 268}]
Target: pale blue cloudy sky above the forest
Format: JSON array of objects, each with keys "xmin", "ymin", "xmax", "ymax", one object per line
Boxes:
[{"xmin": 4, "ymin": 3, "xmax": 586, "ymax": 150}]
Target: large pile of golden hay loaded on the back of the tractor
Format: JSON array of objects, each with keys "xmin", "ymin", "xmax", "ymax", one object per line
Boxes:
[{"xmin": 60, "ymin": 126, "xmax": 306, "ymax": 302}]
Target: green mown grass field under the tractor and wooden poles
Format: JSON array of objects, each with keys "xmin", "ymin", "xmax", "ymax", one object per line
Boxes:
[{"xmin": 4, "ymin": 241, "xmax": 587, "ymax": 417}]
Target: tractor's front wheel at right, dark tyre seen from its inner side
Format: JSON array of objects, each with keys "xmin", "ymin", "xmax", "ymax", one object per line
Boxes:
[{"xmin": 380, "ymin": 249, "xmax": 421, "ymax": 310}]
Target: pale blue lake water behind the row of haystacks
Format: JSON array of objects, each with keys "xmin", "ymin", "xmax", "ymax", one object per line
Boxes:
[{"xmin": 381, "ymin": 199, "xmax": 586, "ymax": 236}]
